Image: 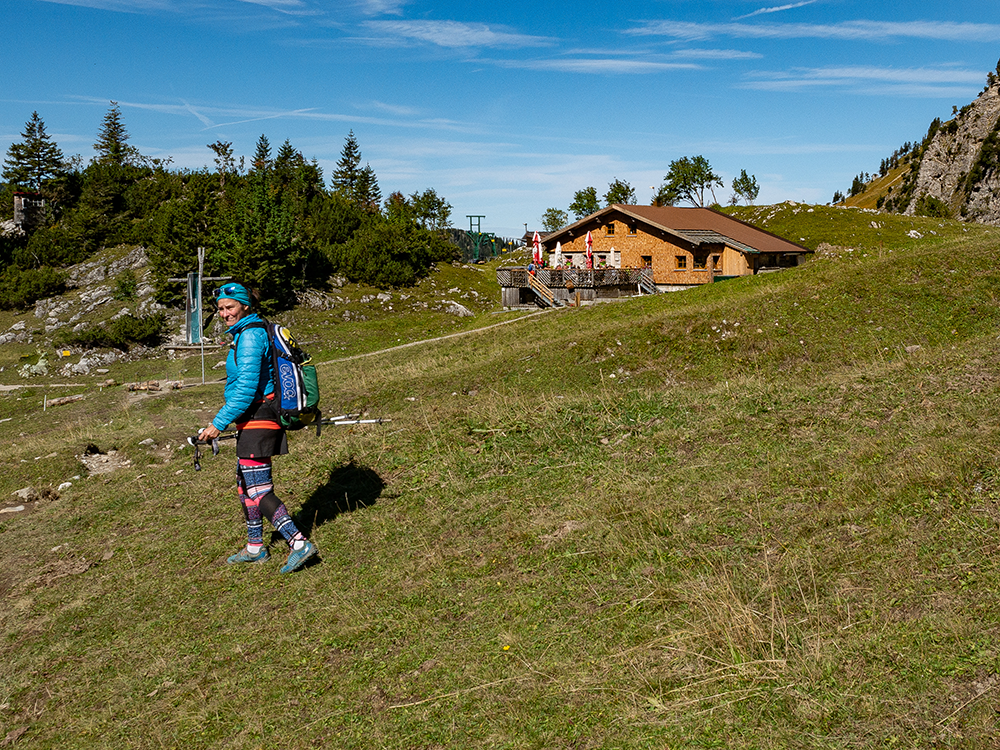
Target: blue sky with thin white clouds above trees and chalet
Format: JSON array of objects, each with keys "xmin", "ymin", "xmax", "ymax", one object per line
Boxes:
[{"xmin": 7, "ymin": 0, "xmax": 1000, "ymax": 236}]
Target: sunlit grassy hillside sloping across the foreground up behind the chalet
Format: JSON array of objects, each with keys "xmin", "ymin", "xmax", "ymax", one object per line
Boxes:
[{"xmin": 0, "ymin": 205, "xmax": 1000, "ymax": 748}]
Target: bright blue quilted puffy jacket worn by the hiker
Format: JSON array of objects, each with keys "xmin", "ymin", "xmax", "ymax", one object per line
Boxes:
[{"xmin": 212, "ymin": 313, "xmax": 274, "ymax": 430}]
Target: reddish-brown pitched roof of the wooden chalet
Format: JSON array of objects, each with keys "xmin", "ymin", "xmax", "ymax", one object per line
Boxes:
[{"xmin": 545, "ymin": 203, "xmax": 812, "ymax": 253}]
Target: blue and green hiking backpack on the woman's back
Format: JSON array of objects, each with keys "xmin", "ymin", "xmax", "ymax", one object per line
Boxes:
[{"xmin": 243, "ymin": 322, "xmax": 323, "ymax": 435}]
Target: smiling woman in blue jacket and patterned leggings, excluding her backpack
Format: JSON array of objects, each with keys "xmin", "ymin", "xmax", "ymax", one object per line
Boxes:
[{"xmin": 199, "ymin": 282, "xmax": 316, "ymax": 573}]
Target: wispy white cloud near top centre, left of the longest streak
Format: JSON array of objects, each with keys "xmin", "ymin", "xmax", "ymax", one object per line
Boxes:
[{"xmin": 364, "ymin": 21, "xmax": 554, "ymax": 49}]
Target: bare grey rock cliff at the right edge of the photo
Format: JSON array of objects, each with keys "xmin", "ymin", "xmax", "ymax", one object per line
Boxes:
[{"xmin": 904, "ymin": 81, "xmax": 1000, "ymax": 224}]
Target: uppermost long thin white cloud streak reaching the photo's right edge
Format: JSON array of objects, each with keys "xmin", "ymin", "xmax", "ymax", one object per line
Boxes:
[{"xmin": 624, "ymin": 21, "xmax": 1000, "ymax": 42}]
